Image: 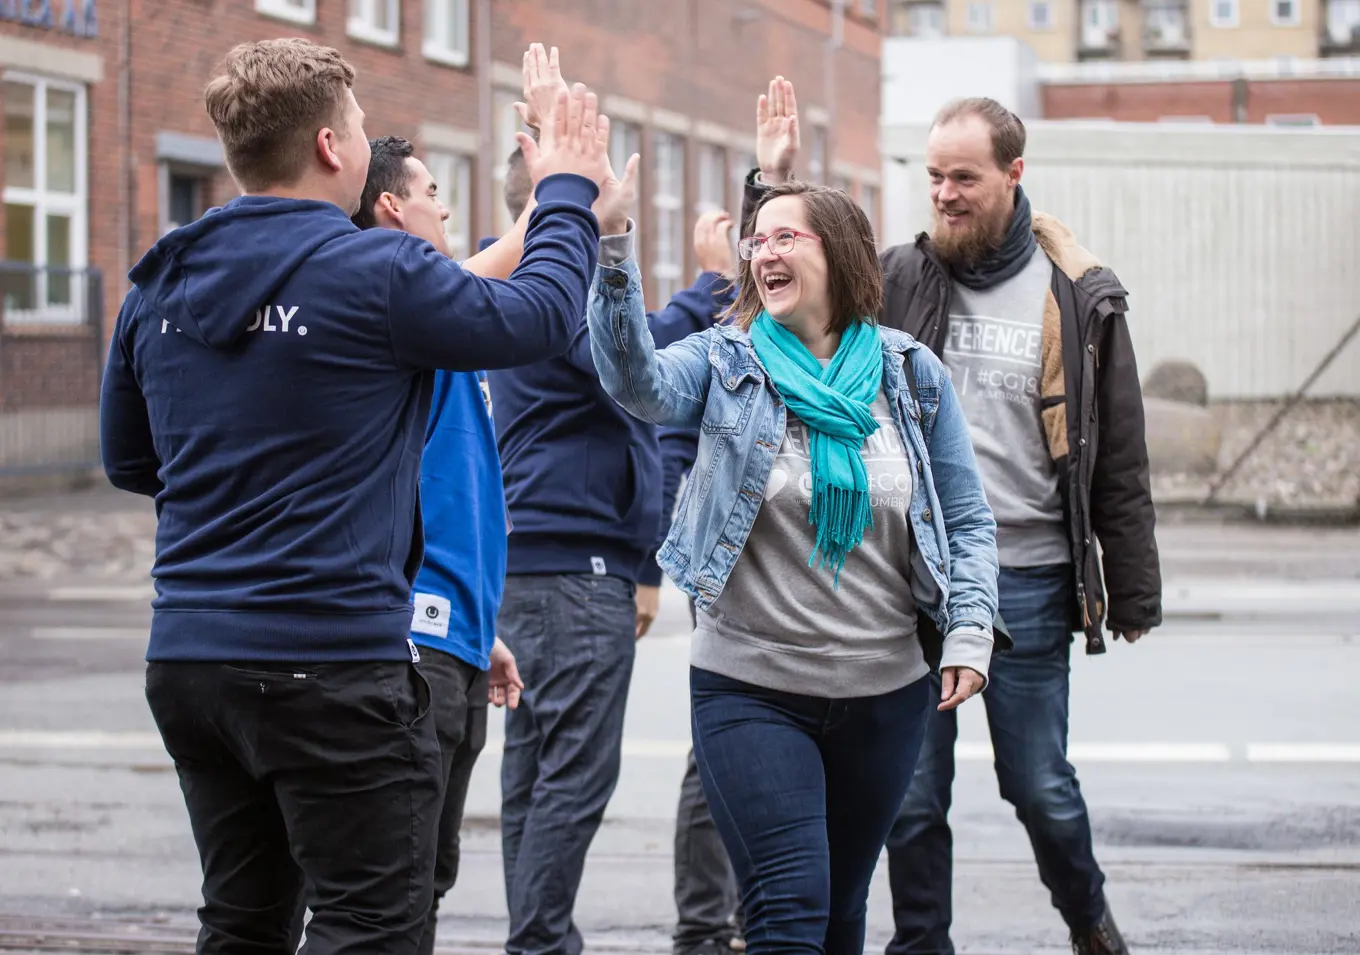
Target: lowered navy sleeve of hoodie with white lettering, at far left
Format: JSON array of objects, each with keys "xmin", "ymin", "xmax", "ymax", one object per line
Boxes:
[{"xmin": 99, "ymin": 288, "xmax": 165, "ymax": 498}]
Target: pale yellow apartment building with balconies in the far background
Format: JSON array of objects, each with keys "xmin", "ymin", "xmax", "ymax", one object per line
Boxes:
[{"xmin": 888, "ymin": 0, "xmax": 1360, "ymax": 63}]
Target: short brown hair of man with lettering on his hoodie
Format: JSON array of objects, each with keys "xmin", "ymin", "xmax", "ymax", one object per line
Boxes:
[{"xmin": 203, "ymin": 37, "xmax": 354, "ymax": 192}]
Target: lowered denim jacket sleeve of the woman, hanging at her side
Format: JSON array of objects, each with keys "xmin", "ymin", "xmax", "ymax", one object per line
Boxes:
[{"xmin": 913, "ymin": 348, "xmax": 1000, "ymax": 677}]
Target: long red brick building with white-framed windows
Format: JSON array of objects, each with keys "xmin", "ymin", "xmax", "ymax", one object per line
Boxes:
[{"xmin": 0, "ymin": 0, "xmax": 883, "ymax": 473}]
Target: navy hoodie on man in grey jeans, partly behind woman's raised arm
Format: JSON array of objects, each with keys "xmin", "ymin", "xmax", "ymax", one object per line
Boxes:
[{"xmin": 488, "ymin": 234, "xmax": 730, "ymax": 586}]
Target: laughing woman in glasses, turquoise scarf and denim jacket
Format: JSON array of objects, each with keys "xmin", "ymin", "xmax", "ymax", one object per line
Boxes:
[{"xmin": 589, "ymin": 175, "xmax": 997, "ymax": 955}]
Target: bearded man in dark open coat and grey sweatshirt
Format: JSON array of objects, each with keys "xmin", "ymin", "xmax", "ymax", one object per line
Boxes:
[{"xmin": 748, "ymin": 88, "xmax": 1161, "ymax": 955}]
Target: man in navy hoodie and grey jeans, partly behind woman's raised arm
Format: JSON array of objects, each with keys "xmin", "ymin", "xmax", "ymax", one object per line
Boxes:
[{"xmin": 490, "ymin": 138, "xmax": 732, "ymax": 955}]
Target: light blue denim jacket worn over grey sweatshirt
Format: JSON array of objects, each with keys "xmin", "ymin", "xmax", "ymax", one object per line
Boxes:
[{"xmin": 586, "ymin": 258, "xmax": 998, "ymax": 676}]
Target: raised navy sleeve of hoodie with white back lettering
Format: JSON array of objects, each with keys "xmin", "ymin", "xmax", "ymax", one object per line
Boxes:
[{"xmin": 388, "ymin": 175, "xmax": 600, "ymax": 371}]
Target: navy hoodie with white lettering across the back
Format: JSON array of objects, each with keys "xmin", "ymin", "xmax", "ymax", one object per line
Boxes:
[{"xmin": 101, "ymin": 175, "xmax": 598, "ymax": 663}]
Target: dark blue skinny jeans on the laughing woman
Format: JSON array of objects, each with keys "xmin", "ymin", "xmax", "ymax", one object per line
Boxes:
[{"xmin": 690, "ymin": 668, "xmax": 929, "ymax": 955}]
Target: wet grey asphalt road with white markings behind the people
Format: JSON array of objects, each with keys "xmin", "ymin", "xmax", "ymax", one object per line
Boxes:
[{"xmin": 0, "ymin": 524, "xmax": 1360, "ymax": 954}]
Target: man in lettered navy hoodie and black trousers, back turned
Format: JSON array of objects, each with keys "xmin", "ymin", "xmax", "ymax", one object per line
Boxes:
[{"xmin": 101, "ymin": 39, "xmax": 608, "ymax": 955}]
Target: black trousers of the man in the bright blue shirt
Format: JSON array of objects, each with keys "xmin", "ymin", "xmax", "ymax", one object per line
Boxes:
[{"xmin": 418, "ymin": 646, "xmax": 491, "ymax": 955}]
